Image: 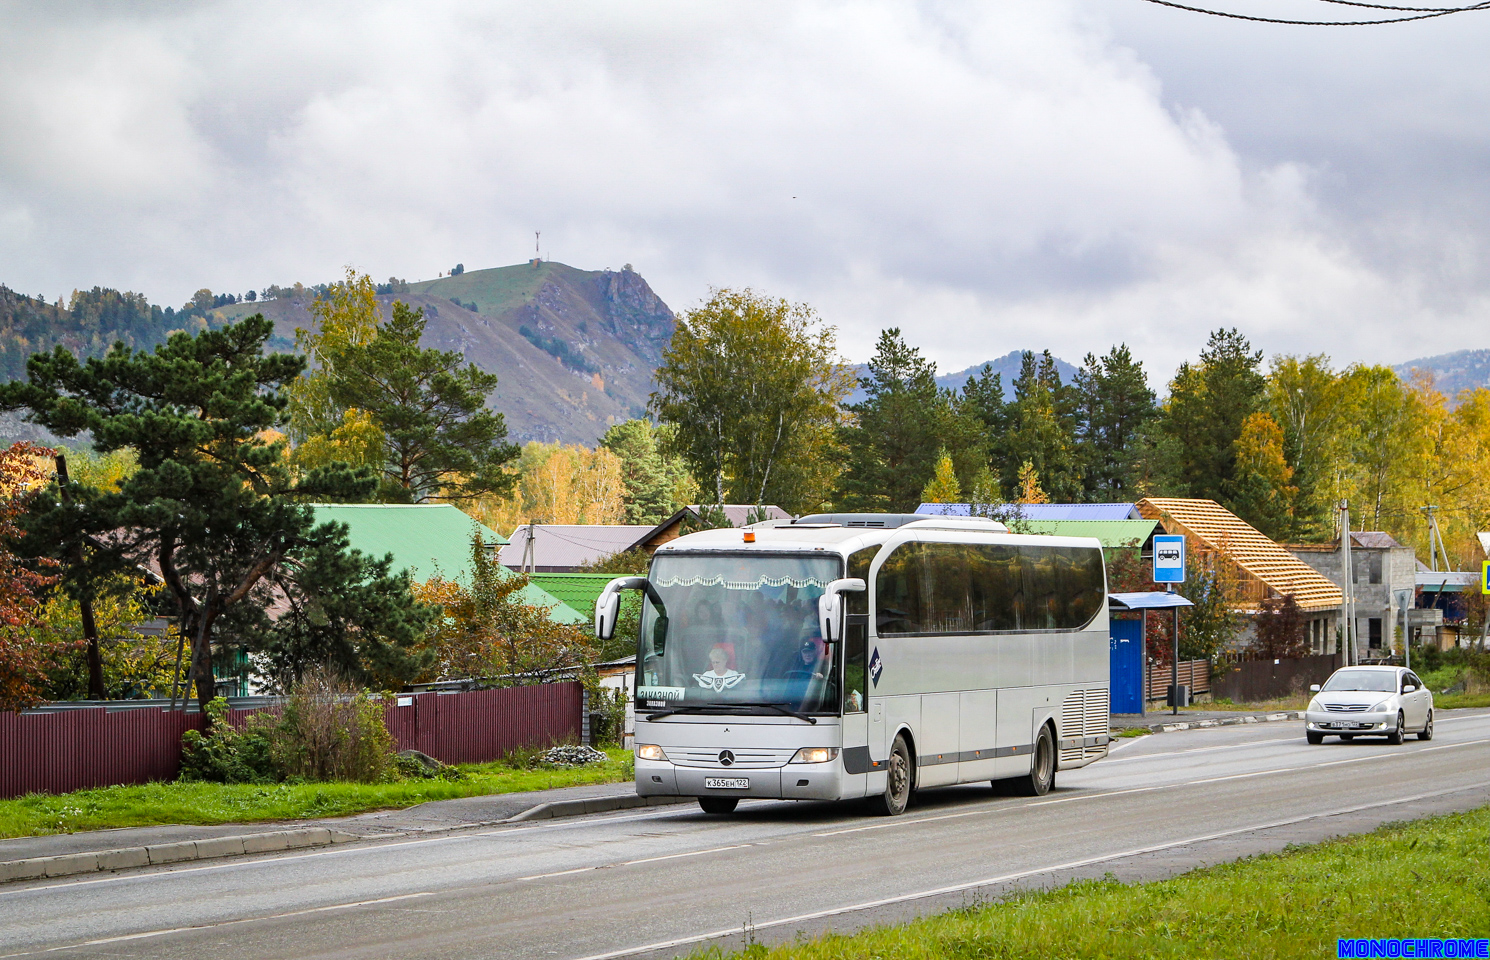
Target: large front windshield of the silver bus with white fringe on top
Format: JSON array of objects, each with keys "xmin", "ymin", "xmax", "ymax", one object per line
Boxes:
[{"xmin": 636, "ymin": 555, "xmax": 842, "ymax": 713}]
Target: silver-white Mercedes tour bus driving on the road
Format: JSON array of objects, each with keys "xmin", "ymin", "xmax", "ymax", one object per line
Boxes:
[{"xmin": 595, "ymin": 514, "xmax": 1109, "ymax": 814}]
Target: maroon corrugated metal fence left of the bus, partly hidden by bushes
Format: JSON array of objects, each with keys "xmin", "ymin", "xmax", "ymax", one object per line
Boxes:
[{"xmin": 0, "ymin": 683, "xmax": 583, "ymax": 798}]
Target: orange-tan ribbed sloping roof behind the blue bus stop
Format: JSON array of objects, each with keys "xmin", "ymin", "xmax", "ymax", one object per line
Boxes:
[{"xmin": 1138, "ymin": 496, "xmax": 1344, "ymax": 610}]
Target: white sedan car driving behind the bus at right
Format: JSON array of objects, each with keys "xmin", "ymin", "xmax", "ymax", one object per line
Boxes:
[{"xmin": 1304, "ymin": 666, "xmax": 1433, "ymax": 744}]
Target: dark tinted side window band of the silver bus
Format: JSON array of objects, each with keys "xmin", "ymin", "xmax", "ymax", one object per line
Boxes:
[{"xmin": 875, "ymin": 543, "xmax": 1104, "ymax": 634}]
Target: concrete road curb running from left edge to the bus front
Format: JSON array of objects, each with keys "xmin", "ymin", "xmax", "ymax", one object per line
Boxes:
[{"xmin": 0, "ymin": 795, "xmax": 693, "ymax": 884}]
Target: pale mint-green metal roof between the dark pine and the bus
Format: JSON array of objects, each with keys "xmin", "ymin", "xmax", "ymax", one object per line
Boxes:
[{"xmin": 305, "ymin": 504, "xmax": 590, "ymax": 623}]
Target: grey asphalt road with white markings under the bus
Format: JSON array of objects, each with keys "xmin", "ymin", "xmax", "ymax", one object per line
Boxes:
[{"xmin": 0, "ymin": 711, "xmax": 1490, "ymax": 960}]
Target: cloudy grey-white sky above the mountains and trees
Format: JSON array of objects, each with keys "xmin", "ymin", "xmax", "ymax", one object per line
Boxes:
[{"xmin": 0, "ymin": 0, "xmax": 1490, "ymax": 379}]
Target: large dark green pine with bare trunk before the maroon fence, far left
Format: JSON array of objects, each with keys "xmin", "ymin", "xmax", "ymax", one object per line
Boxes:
[{"xmin": 0, "ymin": 315, "xmax": 435, "ymax": 708}]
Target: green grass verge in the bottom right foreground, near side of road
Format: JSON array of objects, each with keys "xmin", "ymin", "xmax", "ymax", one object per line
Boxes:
[{"xmin": 694, "ymin": 808, "xmax": 1490, "ymax": 960}]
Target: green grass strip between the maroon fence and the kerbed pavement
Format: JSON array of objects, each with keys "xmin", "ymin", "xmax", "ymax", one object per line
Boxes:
[{"xmin": 0, "ymin": 748, "xmax": 632, "ymax": 838}]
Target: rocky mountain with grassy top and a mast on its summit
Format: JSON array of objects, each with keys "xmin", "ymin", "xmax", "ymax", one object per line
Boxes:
[{"xmin": 213, "ymin": 261, "xmax": 676, "ymax": 446}]
